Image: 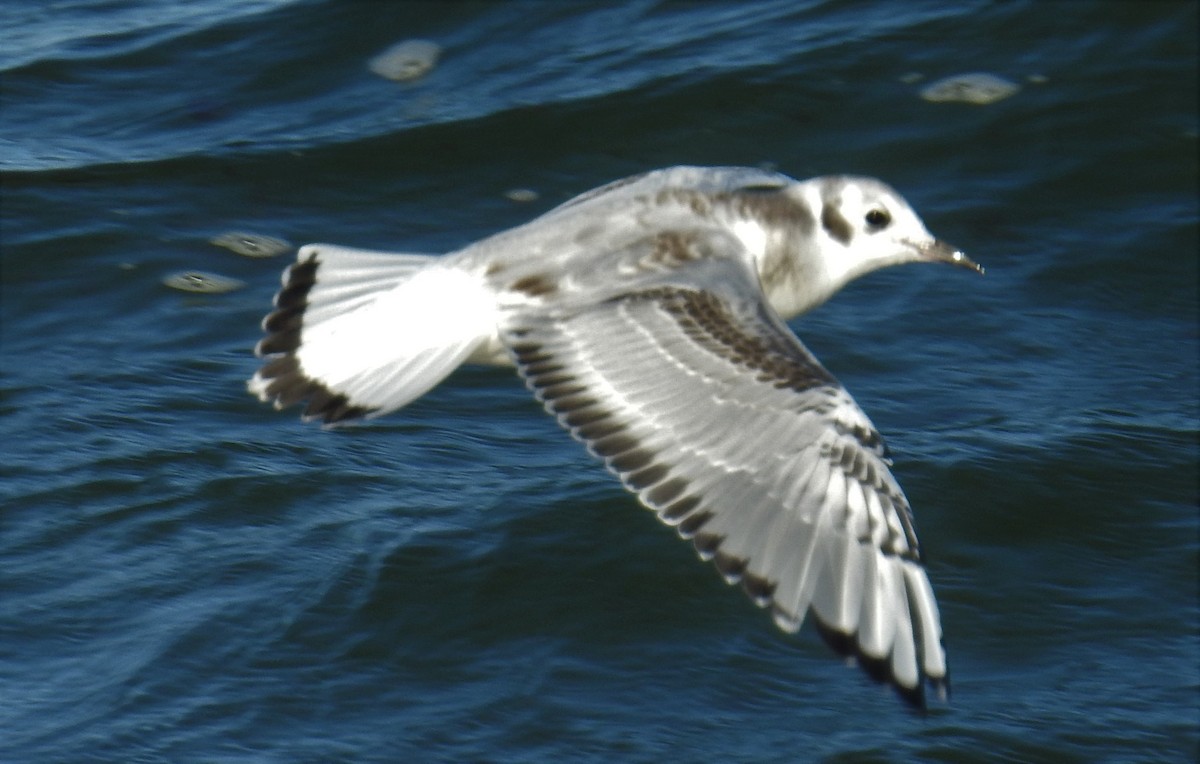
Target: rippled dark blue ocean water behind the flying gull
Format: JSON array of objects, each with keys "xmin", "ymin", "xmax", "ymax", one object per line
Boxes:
[{"xmin": 0, "ymin": 0, "xmax": 1200, "ymax": 763}]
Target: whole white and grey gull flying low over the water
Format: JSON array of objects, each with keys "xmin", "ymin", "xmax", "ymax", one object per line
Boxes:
[{"xmin": 247, "ymin": 167, "xmax": 983, "ymax": 708}]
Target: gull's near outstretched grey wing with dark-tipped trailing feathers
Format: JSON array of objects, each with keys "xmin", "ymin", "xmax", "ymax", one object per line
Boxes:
[{"xmin": 505, "ymin": 236, "xmax": 947, "ymax": 705}]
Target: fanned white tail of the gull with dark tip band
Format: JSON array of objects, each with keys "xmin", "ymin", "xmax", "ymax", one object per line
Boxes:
[{"xmin": 247, "ymin": 245, "xmax": 496, "ymax": 423}]
